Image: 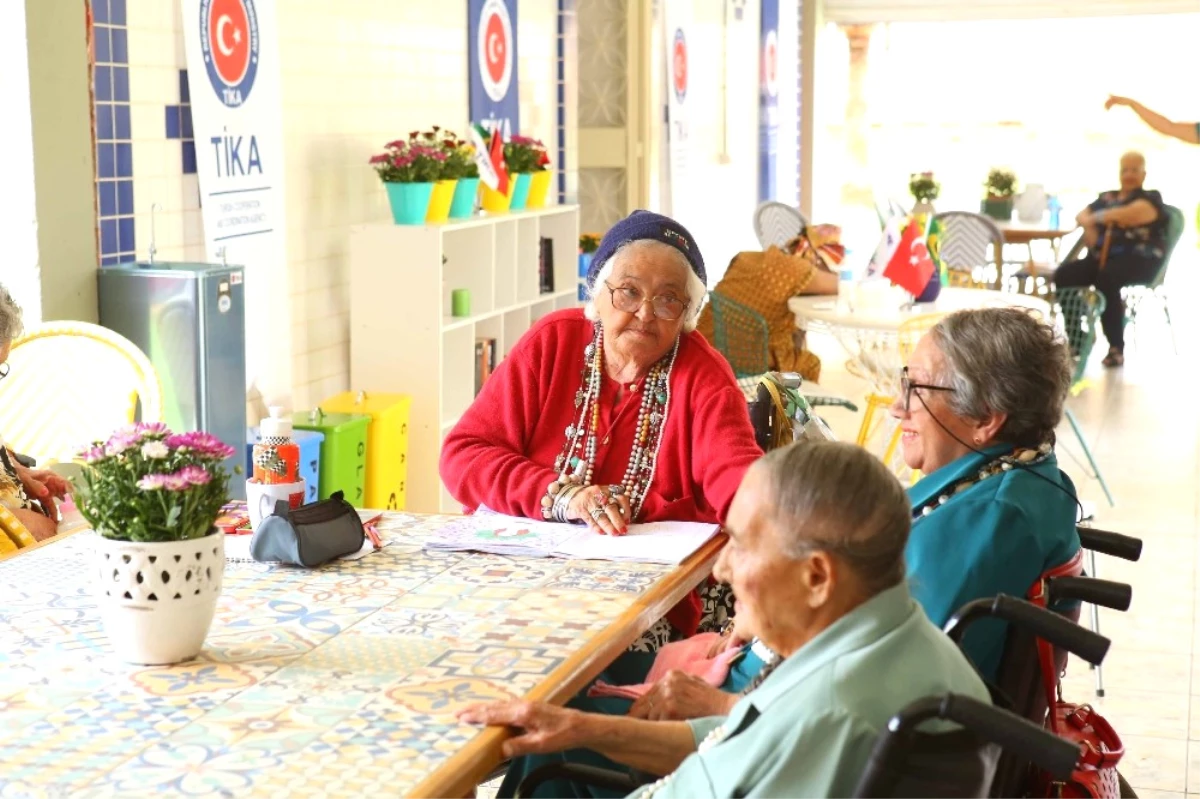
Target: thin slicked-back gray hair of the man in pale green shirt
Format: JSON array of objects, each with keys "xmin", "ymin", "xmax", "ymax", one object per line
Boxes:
[{"xmin": 754, "ymin": 441, "xmax": 912, "ymax": 595}]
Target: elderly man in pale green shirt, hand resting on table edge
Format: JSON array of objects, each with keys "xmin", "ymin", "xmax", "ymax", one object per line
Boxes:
[{"xmin": 461, "ymin": 441, "xmax": 989, "ymax": 798}]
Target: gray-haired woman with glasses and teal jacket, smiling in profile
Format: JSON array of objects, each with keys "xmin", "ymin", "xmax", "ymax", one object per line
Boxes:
[{"xmin": 892, "ymin": 308, "xmax": 1079, "ymax": 679}]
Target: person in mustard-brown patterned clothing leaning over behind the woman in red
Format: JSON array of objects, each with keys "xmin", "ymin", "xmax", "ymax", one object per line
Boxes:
[{"xmin": 696, "ymin": 224, "xmax": 845, "ymax": 382}]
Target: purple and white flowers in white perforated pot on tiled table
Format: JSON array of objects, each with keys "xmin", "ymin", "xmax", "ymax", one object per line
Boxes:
[{"xmin": 76, "ymin": 423, "xmax": 234, "ymax": 665}]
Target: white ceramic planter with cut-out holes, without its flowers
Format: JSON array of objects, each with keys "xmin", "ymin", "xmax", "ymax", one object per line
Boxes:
[{"xmin": 94, "ymin": 531, "xmax": 224, "ymax": 666}]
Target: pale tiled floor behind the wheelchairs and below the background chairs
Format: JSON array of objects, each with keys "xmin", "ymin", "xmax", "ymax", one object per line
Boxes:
[{"xmin": 480, "ymin": 247, "xmax": 1200, "ymax": 799}]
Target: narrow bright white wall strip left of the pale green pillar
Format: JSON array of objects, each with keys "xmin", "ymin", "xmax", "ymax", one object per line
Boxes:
[{"xmin": 0, "ymin": 2, "xmax": 42, "ymax": 325}]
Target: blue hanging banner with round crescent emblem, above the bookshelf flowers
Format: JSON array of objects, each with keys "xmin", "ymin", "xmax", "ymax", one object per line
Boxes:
[{"xmin": 467, "ymin": 0, "xmax": 521, "ymax": 140}]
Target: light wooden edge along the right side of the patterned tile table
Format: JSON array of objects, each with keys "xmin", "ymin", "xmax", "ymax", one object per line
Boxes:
[{"xmin": 408, "ymin": 533, "xmax": 726, "ymax": 799}]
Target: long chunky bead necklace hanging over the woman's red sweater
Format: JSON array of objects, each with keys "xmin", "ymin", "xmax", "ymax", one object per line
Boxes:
[{"xmin": 544, "ymin": 324, "xmax": 679, "ymax": 521}]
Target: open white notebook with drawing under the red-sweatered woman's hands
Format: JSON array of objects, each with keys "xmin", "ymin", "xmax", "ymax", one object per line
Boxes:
[{"xmin": 425, "ymin": 507, "xmax": 720, "ymax": 565}]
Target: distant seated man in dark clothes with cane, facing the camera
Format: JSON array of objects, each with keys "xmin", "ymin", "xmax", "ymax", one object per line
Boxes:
[{"xmin": 1054, "ymin": 152, "xmax": 1168, "ymax": 366}]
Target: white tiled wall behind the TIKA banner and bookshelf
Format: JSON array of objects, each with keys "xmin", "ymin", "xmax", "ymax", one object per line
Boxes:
[{"xmin": 127, "ymin": 0, "xmax": 557, "ymax": 408}]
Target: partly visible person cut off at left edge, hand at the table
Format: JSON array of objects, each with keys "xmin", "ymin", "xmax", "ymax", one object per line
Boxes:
[{"xmin": 0, "ymin": 286, "xmax": 70, "ymax": 541}]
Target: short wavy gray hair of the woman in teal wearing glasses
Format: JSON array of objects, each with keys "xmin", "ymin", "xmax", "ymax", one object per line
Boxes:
[{"xmin": 930, "ymin": 308, "xmax": 1072, "ymax": 446}]
